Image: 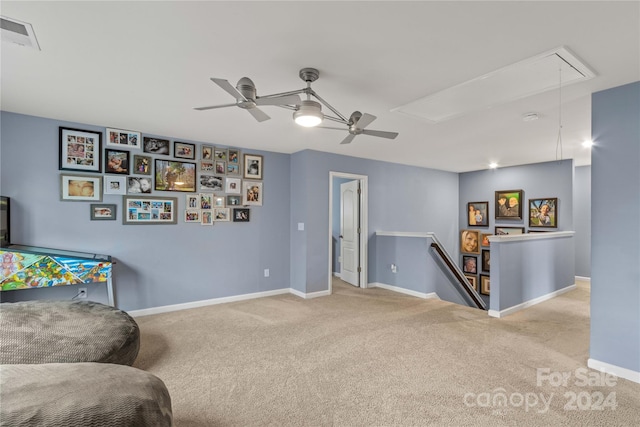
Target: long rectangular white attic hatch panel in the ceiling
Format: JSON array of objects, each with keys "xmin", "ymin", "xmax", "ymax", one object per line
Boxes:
[{"xmin": 391, "ymin": 47, "xmax": 596, "ymax": 123}]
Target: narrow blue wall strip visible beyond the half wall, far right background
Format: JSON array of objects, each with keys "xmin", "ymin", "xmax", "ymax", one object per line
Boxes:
[{"xmin": 573, "ymin": 166, "xmax": 591, "ymax": 277}]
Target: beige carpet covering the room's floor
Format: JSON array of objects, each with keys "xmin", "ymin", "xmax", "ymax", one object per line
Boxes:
[{"xmin": 134, "ymin": 281, "xmax": 640, "ymax": 427}]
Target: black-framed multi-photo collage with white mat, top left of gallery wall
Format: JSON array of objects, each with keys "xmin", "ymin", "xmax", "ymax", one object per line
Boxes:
[{"xmin": 58, "ymin": 126, "xmax": 102, "ymax": 173}]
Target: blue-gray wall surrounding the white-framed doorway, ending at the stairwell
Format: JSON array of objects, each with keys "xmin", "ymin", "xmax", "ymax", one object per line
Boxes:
[{"xmin": 291, "ymin": 150, "xmax": 458, "ymax": 293}]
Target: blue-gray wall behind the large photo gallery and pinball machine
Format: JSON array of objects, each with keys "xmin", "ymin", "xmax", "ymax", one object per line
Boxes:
[{"xmin": 0, "ymin": 112, "xmax": 291, "ymax": 310}]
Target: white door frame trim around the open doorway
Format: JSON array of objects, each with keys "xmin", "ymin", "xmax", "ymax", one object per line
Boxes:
[{"xmin": 327, "ymin": 171, "xmax": 369, "ymax": 294}]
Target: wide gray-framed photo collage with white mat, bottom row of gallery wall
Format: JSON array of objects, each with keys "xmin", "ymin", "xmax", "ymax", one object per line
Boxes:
[{"xmin": 122, "ymin": 196, "xmax": 178, "ymax": 225}]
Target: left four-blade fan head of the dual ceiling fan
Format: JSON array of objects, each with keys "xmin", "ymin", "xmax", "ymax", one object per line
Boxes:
[{"xmin": 194, "ymin": 77, "xmax": 300, "ymax": 122}]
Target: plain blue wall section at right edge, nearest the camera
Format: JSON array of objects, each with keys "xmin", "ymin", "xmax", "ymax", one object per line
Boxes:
[{"xmin": 590, "ymin": 82, "xmax": 640, "ymax": 373}]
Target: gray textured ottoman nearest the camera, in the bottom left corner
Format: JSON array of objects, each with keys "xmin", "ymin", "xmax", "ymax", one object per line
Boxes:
[{"xmin": 0, "ymin": 363, "xmax": 173, "ymax": 427}]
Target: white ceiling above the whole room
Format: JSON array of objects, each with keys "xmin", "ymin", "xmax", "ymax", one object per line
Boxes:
[{"xmin": 0, "ymin": 0, "xmax": 640, "ymax": 172}]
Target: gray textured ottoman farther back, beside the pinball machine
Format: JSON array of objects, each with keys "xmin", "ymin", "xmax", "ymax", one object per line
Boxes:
[{"xmin": 0, "ymin": 300, "xmax": 140, "ymax": 365}]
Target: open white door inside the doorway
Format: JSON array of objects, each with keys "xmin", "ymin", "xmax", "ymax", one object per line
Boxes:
[{"xmin": 340, "ymin": 180, "xmax": 360, "ymax": 286}]
